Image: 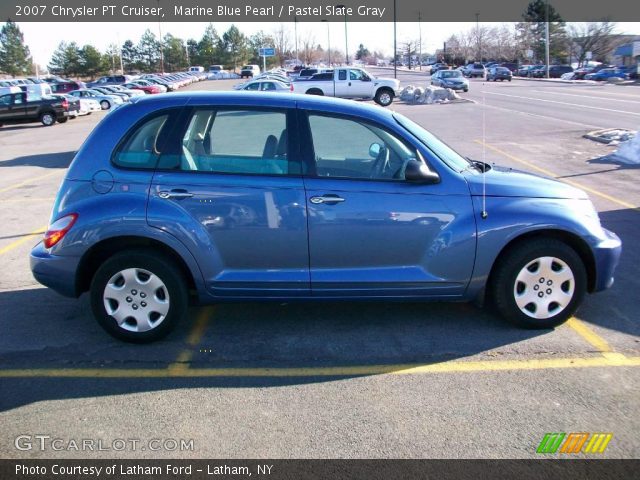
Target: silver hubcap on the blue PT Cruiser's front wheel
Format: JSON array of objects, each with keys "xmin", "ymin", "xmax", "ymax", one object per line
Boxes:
[{"xmin": 513, "ymin": 257, "xmax": 575, "ymax": 319}]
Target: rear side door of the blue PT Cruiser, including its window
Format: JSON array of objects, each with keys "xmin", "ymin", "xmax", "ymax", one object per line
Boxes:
[{"xmin": 148, "ymin": 106, "xmax": 310, "ymax": 297}]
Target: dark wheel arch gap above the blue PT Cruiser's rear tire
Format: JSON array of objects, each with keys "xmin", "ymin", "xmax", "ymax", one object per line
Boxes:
[{"xmin": 76, "ymin": 235, "xmax": 197, "ymax": 296}]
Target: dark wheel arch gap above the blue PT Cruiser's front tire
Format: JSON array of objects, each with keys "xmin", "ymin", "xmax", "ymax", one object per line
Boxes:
[{"xmin": 484, "ymin": 228, "xmax": 596, "ymax": 295}]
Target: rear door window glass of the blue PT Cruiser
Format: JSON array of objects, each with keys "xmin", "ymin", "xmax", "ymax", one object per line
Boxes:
[{"xmin": 179, "ymin": 109, "xmax": 290, "ymax": 175}]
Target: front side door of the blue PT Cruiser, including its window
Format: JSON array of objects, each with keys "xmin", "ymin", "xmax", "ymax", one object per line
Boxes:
[{"xmin": 302, "ymin": 112, "xmax": 475, "ymax": 297}]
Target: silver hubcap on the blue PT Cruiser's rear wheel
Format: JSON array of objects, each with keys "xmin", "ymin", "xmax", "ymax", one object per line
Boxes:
[{"xmin": 102, "ymin": 268, "xmax": 169, "ymax": 332}]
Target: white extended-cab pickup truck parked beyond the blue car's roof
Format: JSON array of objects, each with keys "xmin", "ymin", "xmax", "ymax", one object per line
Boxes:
[{"xmin": 292, "ymin": 68, "xmax": 400, "ymax": 107}]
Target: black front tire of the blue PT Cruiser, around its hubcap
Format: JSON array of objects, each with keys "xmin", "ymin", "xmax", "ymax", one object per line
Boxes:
[{"xmin": 488, "ymin": 238, "xmax": 587, "ymax": 329}]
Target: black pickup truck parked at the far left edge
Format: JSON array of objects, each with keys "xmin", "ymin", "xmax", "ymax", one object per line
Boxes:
[{"xmin": 0, "ymin": 92, "xmax": 69, "ymax": 127}]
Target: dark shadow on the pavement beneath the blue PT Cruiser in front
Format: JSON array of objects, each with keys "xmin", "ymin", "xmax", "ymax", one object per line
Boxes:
[{"xmin": 0, "ymin": 288, "xmax": 549, "ymax": 411}]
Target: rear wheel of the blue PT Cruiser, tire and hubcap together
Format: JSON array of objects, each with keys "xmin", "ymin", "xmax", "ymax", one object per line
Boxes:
[{"xmin": 90, "ymin": 250, "xmax": 188, "ymax": 343}]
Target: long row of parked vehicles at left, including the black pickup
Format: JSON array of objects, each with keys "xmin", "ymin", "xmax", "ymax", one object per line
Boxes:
[{"xmin": 0, "ymin": 72, "xmax": 206, "ymax": 126}]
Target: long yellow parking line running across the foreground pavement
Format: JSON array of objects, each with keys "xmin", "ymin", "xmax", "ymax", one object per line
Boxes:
[{"xmin": 0, "ymin": 354, "xmax": 640, "ymax": 378}]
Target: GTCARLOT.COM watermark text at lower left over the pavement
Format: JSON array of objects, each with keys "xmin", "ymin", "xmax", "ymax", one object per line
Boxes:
[{"xmin": 13, "ymin": 435, "xmax": 195, "ymax": 452}]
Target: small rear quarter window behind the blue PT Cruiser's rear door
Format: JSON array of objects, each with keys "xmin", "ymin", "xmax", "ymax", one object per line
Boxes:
[{"xmin": 113, "ymin": 114, "xmax": 169, "ymax": 168}]
